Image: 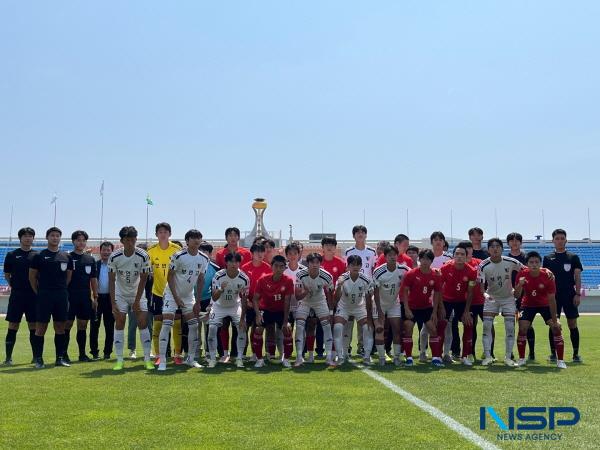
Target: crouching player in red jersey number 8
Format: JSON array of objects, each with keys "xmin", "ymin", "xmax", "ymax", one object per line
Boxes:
[{"xmin": 400, "ymin": 250, "xmax": 444, "ymax": 367}]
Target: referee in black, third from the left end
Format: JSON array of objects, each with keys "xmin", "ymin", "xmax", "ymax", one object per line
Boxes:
[{"xmin": 63, "ymin": 230, "xmax": 98, "ymax": 364}]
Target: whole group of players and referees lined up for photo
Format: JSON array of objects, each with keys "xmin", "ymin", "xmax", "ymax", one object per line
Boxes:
[{"xmin": 4, "ymin": 223, "xmax": 583, "ymax": 371}]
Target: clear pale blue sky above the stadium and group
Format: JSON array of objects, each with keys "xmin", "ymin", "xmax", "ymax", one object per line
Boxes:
[{"xmin": 0, "ymin": 0, "xmax": 600, "ymax": 243}]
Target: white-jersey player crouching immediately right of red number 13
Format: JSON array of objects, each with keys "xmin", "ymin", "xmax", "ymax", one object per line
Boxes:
[{"xmin": 294, "ymin": 253, "xmax": 334, "ymax": 367}]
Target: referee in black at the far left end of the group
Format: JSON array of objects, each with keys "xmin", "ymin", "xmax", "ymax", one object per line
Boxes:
[{"xmin": 4, "ymin": 227, "xmax": 37, "ymax": 366}]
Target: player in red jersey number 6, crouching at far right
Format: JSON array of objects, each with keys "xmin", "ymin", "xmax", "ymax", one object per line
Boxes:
[{"xmin": 515, "ymin": 252, "xmax": 567, "ymax": 369}]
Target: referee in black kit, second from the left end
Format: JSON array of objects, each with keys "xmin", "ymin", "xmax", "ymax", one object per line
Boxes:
[{"xmin": 29, "ymin": 227, "xmax": 73, "ymax": 369}]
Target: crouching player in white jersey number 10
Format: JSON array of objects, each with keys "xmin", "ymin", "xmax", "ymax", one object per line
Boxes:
[{"xmin": 208, "ymin": 253, "xmax": 250, "ymax": 368}]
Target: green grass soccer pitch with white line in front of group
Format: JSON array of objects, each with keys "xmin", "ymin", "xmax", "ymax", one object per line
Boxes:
[{"xmin": 0, "ymin": 316, "xmax": 600, "ymax": 448}]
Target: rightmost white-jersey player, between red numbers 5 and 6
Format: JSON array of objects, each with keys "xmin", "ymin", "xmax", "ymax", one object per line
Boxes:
[{"xmin": 479, "ymin": 238, "xmax": 524, "ymax": 367}]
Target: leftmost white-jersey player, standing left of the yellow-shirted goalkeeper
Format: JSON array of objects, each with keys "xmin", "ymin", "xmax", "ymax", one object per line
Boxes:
[{"xmin": 108, "ymin": 227, "xmax": 154, "ymax": 370}]
